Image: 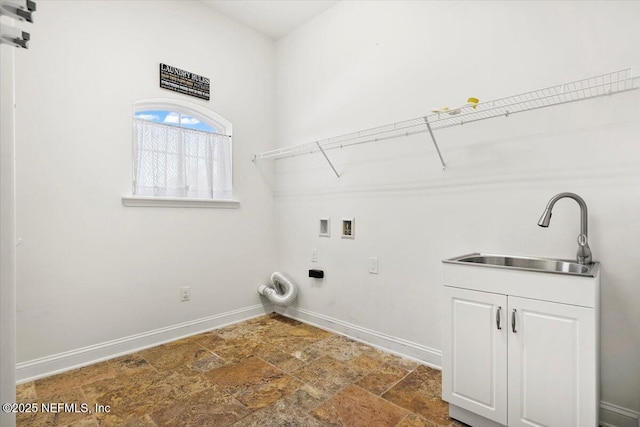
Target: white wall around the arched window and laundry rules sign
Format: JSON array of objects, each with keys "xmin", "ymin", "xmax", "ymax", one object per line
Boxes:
[{"xmin": 16, "ymin": 1, "xmax": 275, "ymax": 363}]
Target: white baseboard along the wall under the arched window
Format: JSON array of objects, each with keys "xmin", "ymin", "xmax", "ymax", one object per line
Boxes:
[{"xmin": 16, "ymin": 304, "xmax": 273, "ymax": 384}]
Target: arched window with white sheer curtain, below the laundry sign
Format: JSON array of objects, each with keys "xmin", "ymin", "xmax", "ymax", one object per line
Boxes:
[{"xmin": 133, "ymin": 99, "xmax": 233, "ymax": 200}]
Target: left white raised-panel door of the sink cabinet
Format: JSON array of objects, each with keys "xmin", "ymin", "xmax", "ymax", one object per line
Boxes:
[{"xmin": 442, "ymin": 286, "xmax": 508, "ymax": 425}]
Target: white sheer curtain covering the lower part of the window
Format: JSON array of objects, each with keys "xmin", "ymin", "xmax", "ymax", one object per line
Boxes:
[{"xmin": 133, "ymin": 119, "xmax": 233, "ymax": 200}]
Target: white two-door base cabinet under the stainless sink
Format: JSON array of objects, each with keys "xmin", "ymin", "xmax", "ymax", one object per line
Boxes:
[{"xmin": 442, "ymin": 264, "xmax": 599, "ymax": 427}]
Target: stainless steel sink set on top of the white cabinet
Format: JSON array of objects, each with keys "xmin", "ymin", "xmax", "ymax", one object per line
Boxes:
[{"xmin": 443, "ymin": 253, "xmax": 597, "ymax": 277}]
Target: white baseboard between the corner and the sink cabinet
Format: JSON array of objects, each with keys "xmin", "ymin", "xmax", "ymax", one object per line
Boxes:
[{"xmin": 274, "ymin": 306, "xmax": 442, "ymax": 369}]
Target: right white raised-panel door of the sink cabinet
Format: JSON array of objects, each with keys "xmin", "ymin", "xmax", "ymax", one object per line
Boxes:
[{"xmin": 508, "ymin": 297, "xmax": 598, "ymax": 427}]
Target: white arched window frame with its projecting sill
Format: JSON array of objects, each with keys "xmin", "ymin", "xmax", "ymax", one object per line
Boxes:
[{"xmin": 122, "ymin": 98, "xmax": 240, "ymax": 209}]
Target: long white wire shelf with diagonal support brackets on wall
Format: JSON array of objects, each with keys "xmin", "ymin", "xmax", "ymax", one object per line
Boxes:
[{"xmin": 253, "ymin": 68, "xmax": 640, "ymax": 168}]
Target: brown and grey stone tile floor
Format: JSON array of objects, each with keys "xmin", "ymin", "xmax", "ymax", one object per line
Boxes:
[{"xmin": 17, "ymin": 313, "xmax": 464, "ymax": 427}]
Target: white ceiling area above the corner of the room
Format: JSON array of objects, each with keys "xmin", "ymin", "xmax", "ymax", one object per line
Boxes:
[{"xmin": 201, "ymin": 0, "xmax": 338, "ymax": 40}]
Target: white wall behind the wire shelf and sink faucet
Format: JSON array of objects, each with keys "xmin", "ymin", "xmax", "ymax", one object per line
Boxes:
[{"xmin": 274, "ymin": 1, "xmax": 640, "ymax": 418}]
